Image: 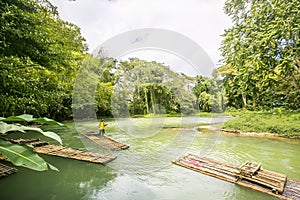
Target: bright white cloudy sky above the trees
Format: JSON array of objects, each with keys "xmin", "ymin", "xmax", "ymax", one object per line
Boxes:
[{"xmin": 50, "ymin": 0, "xmax": 231, "ymax": 75}]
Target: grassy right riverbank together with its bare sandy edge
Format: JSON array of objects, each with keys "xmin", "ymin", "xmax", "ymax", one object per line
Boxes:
[{"xmin": 199, "ymin": 110, "xmax": 300, "ymax": 139}]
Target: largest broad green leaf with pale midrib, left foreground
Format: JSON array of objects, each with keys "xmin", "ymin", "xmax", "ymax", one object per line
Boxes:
[{"xmin": 0, "ymin": 140, "xmax": 48, "ymax": 171}]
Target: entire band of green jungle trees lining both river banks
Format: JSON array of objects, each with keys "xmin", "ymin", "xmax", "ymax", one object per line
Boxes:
[{"xmin": 0, "ymin": 0, "xmax": 300, "ymax": 120}]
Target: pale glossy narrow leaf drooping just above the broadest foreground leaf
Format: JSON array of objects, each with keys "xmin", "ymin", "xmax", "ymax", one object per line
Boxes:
[{"xmin": 0, "ymin": 122, "xmax": 62, "ymax": 144}]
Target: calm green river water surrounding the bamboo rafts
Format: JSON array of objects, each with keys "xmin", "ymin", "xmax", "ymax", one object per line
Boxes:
[{"xmin": 0, "ymin": 117, "xmax": 300, "ymax": 200}]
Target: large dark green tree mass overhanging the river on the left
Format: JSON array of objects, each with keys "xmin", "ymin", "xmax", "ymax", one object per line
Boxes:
[{"xmin": 0, "ymin": 0, "xmax": 86, "ymax": 119}]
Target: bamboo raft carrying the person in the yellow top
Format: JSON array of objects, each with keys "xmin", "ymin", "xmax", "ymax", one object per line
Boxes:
[{"xmin": 80, "ymin": 131, "xmax": 129, "ymax": 151}]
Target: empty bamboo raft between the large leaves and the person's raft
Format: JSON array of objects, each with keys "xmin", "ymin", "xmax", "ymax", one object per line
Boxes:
[{"xmin": 13, "ymin": 139, "xmax": 117, "ymax": 164}]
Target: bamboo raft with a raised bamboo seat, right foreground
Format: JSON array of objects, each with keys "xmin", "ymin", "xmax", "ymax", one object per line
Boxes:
[{"xmin": 172, "ymin": 154, "xmax": 300, "ymax": 200}]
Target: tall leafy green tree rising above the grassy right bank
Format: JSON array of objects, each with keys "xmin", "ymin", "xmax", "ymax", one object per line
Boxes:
[{"xmin": 219, "ymin": 0, "xmax": 300, "ymax": 108}]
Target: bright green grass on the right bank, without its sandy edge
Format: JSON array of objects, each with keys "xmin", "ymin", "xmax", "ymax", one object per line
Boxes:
[{"xmin": 223, "ymin": 112, "xmax": 300, "ymax": 138}]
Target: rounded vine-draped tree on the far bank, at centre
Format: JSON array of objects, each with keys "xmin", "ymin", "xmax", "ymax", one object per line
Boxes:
[{"xmin": 112, "ymin": 58, "xmax": 196, "ymax": 114}]
